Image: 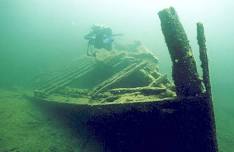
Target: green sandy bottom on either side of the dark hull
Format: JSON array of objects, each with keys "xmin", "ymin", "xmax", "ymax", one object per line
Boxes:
[{"xmin": 0, "ymin": 89, "xmax": 234, "ymax": 152}]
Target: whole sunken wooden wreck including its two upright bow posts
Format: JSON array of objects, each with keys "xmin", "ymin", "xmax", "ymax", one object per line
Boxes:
[{"xmin": 35, "ymin": 8, "xmax": 218, "ymax": 152}]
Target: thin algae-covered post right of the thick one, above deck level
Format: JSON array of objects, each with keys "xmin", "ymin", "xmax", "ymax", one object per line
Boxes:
[{"xmin": 197, "ymin": 23, "xmax": 212, "ymax": 97}]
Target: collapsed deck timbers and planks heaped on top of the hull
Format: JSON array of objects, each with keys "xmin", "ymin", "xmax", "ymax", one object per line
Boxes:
[{"xmin": 34, "ymin": 51, "xmax": 176, "ymax": 104}]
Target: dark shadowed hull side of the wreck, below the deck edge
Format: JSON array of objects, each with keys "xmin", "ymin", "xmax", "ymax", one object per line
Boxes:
[{"xmin": 33, "ymin": 96, "xmax": 217, "ymax": 152}]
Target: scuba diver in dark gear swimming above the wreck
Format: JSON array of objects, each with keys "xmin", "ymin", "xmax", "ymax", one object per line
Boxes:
[{"xmin": 84, "ymin": 25, "xmax": 121, "ymax": 57}]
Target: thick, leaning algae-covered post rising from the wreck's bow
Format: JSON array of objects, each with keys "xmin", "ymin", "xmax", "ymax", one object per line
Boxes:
[{"xmin": 158, "ymin": 7, "xmax": 202, "ymax": 97}]
